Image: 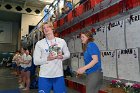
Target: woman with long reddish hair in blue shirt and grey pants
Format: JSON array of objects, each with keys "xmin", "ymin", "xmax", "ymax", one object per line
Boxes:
[{"xmin": 77, "ymin": 31, "xmax": 103, "ymax": 93}]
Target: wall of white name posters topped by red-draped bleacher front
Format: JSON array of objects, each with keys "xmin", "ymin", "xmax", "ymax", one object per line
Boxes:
[{"xmin": 54, "ymin": 0, "xmax": 140, "ymax": 82}]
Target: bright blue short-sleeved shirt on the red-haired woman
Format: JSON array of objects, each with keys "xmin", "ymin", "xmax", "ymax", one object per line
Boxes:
[{"xmin": 84, "ymin": 42, "xmax": 101, "ymax": 74}]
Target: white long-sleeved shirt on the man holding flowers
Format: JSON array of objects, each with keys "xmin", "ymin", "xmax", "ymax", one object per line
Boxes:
[{"xmin": 33, "ymin": 37, "xmax": 70, "ymax": 78}]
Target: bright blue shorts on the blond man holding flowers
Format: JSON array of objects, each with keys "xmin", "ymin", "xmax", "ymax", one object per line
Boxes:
[{"xmin": 38, "ymin": 76, "xmax": 66, "ymax": 93}]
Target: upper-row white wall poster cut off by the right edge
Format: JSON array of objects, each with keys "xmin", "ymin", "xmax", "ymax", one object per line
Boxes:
[{"xmin": 125, "ymin": 12, "xmax": 140, "ymax": 48}]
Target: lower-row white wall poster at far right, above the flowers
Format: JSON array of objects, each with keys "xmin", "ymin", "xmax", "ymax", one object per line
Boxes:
[{"xmin": 117, "ymin": 48, "xmax": 140, "ymax": 82}]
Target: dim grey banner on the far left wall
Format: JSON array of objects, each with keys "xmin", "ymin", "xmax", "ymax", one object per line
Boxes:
[{"xmin": 0, "ymin": 21, "xmax": 12, "ymax": 43}]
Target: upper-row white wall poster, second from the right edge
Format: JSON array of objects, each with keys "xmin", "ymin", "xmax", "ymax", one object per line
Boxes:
[{"xmin": 107, "ymin": 20, "xmax": 126, "ymax": 50}]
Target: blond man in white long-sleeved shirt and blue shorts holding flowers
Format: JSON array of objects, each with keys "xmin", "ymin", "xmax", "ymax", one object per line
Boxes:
[{"xmin": 33, "ymin": 22, "xmax": 70, "ymax": 93}]
